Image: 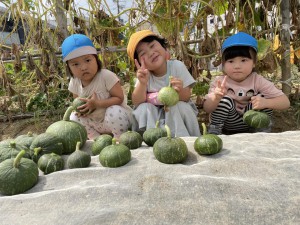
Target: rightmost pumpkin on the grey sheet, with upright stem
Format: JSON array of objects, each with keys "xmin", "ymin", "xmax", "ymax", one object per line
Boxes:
[{"xmin": 194, "ymin": 123, "xmax": 223, "ymax": 155}]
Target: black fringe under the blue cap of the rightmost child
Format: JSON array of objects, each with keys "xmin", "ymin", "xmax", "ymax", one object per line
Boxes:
[{"xmin": 222, "ymin": 46, "xmax": 256, "ymax": 63}]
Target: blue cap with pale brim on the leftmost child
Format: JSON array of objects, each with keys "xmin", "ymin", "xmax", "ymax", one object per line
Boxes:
[{"xmin": 61, "ymin": 34, "xmax": 97, "ymax": 62}]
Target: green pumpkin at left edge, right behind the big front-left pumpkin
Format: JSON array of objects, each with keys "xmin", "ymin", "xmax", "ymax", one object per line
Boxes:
[{"xmin": 0, "ymin": 139, "xmax": 30, "ymax": 163}]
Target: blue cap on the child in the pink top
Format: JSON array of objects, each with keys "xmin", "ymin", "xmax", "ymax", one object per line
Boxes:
[{"xmin": 222, "ymin": 32, "xmax": 257, "ymax": 53}]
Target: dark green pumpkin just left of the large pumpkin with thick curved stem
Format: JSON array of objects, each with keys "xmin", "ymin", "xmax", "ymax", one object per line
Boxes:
[{"xmin": 30, "ymin": 133, "xmax": 64, "ymax": 162}]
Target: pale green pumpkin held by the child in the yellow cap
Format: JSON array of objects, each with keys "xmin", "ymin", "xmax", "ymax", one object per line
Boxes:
[{"xmin": 157, "ymin": 76, "xmax": 179, "ymax": 111}]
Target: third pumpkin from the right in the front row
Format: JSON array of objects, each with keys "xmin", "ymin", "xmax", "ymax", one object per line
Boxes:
[{"xmin": 99, "ymin": 138, "xmax": 131, "ymax": 168}]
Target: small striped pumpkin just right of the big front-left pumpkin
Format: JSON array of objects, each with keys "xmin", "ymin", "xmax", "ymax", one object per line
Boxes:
[{"xmin": 38, "ymin": 152, "xmax": 64, "ymax": 174}]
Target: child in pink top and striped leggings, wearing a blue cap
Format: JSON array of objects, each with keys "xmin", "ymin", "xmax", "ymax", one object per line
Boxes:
[{"xmin": 203, "ymin": 32, "xmax": 290, "ymax": 134}]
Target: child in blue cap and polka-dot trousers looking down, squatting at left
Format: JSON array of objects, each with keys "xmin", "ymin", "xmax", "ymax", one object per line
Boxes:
[{"xmin": 62, "ymin": 34, "xmax": 131, "ymax": 140}]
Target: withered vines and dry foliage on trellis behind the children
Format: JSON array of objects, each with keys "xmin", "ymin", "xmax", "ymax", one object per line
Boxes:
[{"xmin": 0, "ymin": 0, "xmax": 300, "ymax": 139}]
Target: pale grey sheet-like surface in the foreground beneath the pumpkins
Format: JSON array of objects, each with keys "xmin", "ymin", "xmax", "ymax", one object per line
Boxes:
[{"xmin": 0, "ymin": 131, "xmax": 300, "ymax": 225}]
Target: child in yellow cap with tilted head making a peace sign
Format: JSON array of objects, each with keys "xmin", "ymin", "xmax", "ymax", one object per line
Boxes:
[{"xmin": 127, "ymin": 30, "xmax": 200, "ymax": 137}]
